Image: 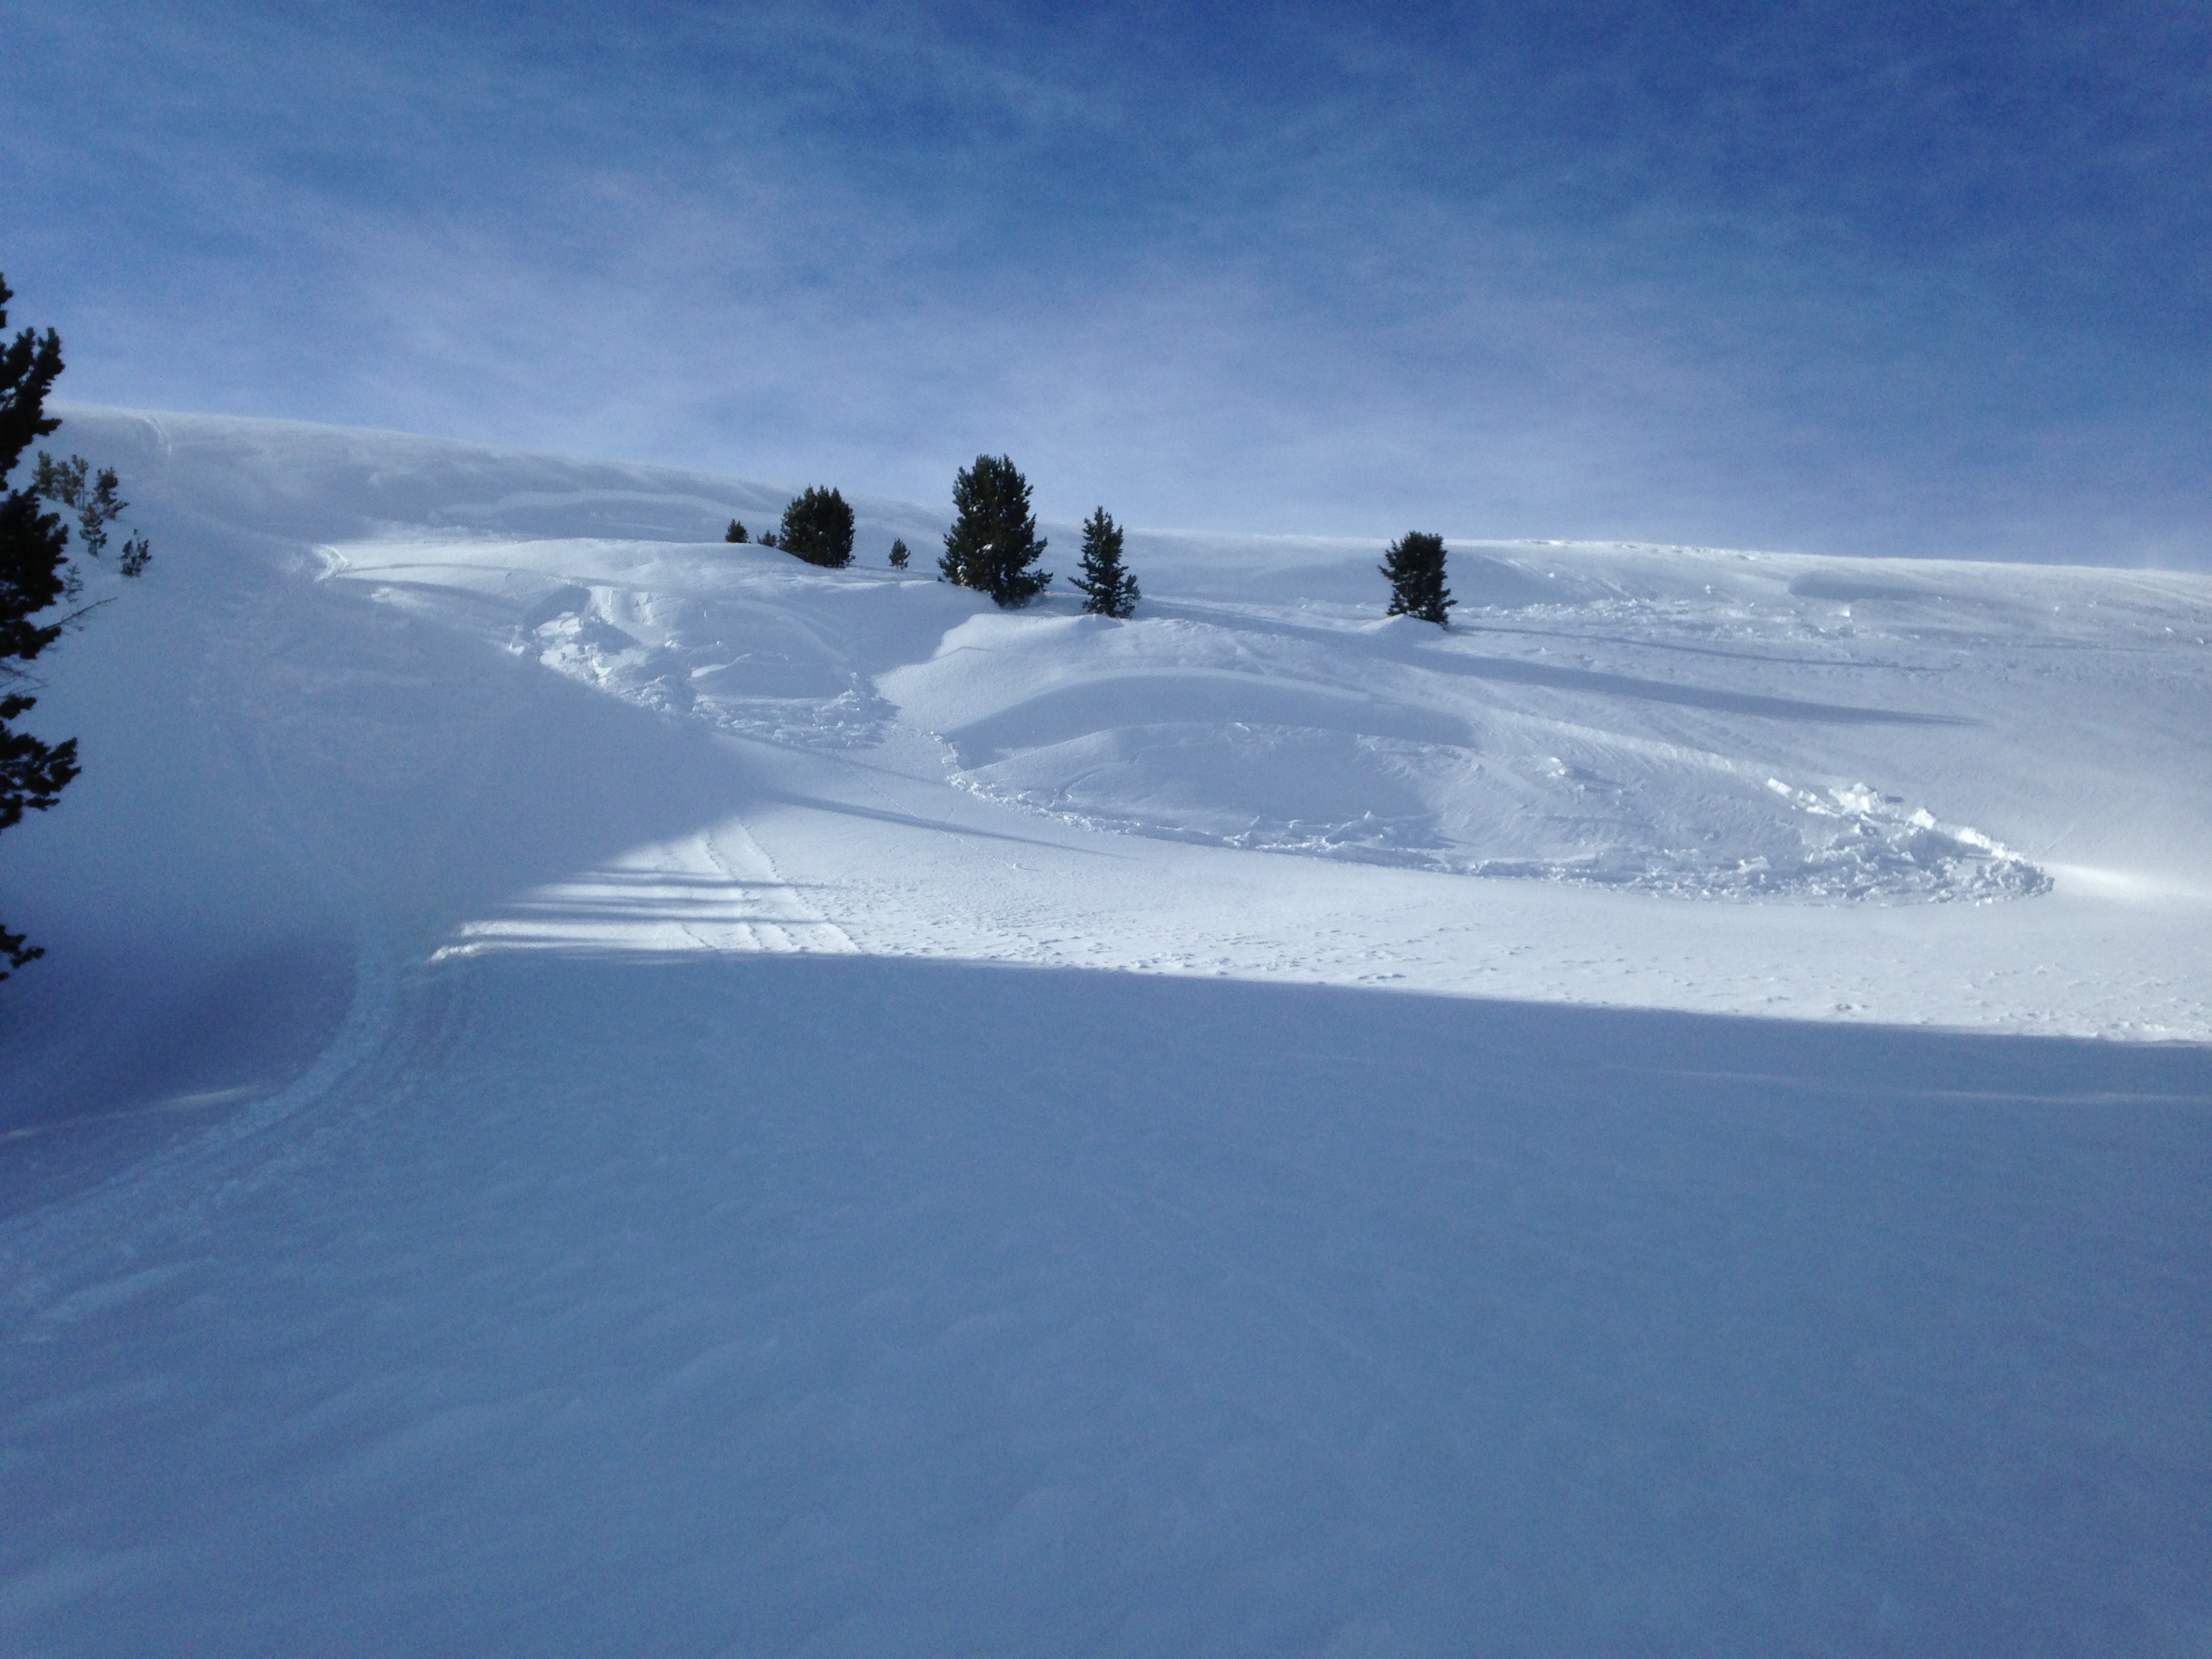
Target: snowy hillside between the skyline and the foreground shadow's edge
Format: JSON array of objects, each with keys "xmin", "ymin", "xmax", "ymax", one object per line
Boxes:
[{"xmin": 17, "ymin": 409, "xmax": 2212, "ymax": 1070}]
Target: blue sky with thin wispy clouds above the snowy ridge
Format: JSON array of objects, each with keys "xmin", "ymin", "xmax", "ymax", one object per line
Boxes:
[{"xmin": 0, "ymin": 0, "xmax": 2212, "ymax": 567}]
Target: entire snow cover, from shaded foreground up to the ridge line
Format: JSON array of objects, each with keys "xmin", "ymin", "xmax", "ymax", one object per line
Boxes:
[{"xmin": 0, "ymin": 409, "xmax": 2212, "ymax": 1654}]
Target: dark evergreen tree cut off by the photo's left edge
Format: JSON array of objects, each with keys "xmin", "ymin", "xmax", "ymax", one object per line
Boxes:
[{"xmin": 0, "ymin": 279, "xmax": 152, "ymax": 980}]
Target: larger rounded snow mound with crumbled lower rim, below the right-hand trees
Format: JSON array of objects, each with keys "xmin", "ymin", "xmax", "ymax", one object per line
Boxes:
[{"xmin": 882, "ymin": 609, "xmax": 2051, "ymax": 903}]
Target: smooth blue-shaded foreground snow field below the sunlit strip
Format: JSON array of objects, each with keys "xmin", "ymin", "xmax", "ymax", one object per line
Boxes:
[{"xmin": 0, "ymin": 954, "xmax": 2212, "ymax": 1654}]
